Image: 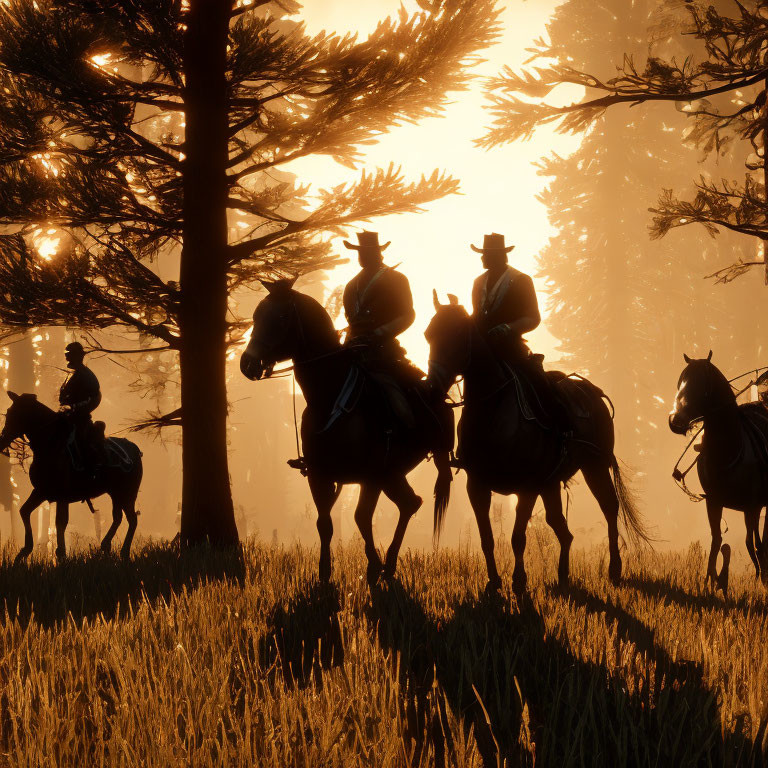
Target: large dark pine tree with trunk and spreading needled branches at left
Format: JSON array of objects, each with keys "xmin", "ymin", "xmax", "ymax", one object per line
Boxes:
[{"xmin": 0, "ymin": 0, "xmax": 497, "ymax": 543}]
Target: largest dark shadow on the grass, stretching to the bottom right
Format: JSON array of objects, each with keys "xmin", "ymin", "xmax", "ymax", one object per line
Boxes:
[{"xmin": 370, "ymin": 583, "xmax": 757, "ymax": 766}]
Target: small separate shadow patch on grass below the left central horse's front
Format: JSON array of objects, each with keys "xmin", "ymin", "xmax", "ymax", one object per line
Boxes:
[{"xmin": 259, "ymin": 581, "xmax": 344, "ymax": 689}]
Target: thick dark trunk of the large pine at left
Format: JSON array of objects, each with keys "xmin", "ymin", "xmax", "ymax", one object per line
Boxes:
[{"xmin": 179, "ymin": 0, "xmax": 238, "ymax": 544}]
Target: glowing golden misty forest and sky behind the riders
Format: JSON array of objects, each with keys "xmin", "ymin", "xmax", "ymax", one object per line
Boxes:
[{"xmin": 0, "ymin": 0, "xmax": 768, "ymax": 560}]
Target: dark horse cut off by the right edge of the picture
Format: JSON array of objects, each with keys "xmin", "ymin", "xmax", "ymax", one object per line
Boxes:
[{"xmin": 669, "ymin": 351, "xmax": 768, "ymax": 587}]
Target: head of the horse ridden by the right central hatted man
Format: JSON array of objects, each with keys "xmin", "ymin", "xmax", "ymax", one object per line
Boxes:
[{"xmin": 424, "ymin": 291, "xmax": 472, "ymax": 392}]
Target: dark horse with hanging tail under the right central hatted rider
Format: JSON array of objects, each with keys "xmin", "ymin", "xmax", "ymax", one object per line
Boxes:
[{"xmin": 425, "ymin": 294, "xmax": 650, "ymax": 594}]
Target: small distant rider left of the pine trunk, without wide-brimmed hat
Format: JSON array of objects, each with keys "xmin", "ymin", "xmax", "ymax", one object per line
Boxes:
[{"xmin": 59, "ymin": 341, "xmax": 104, "ymax": 470}]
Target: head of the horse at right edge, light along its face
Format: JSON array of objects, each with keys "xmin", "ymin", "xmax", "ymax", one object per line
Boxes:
[{"xmin": 669, "ymin": 350, "xmax": 736, "ymax": 435}]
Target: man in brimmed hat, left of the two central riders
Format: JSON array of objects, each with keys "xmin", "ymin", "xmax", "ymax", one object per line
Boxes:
[{"xmin": 344, "ymin": 231, "xmax": 422, "ymax": 426}]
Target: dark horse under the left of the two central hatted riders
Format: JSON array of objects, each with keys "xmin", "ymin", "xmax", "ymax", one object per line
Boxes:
[{"xmin": 240, "ymin": 280, "xmax": 454, "ymax": 586}]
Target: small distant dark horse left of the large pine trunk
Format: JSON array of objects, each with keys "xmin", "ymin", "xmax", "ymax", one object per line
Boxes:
[{"xmin": 0, "ymin": 392, "xmax": 143, "ymax": 562}]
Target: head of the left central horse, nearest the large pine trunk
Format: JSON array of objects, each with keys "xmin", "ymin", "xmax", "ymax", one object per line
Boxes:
[{"xmin": 240, "ymin": 277, "xmax": 338, "ymax": 381}]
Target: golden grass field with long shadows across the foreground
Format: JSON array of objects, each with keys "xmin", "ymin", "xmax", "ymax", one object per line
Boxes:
[{"xmin": 0, "ymin": 537, "xmax": 768, "ymax": 767}]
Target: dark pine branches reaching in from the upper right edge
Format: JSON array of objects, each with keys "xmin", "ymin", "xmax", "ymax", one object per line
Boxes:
[{"xmin": 481, "ymin": 0, "xmax": 768, "ymax": 283}]
